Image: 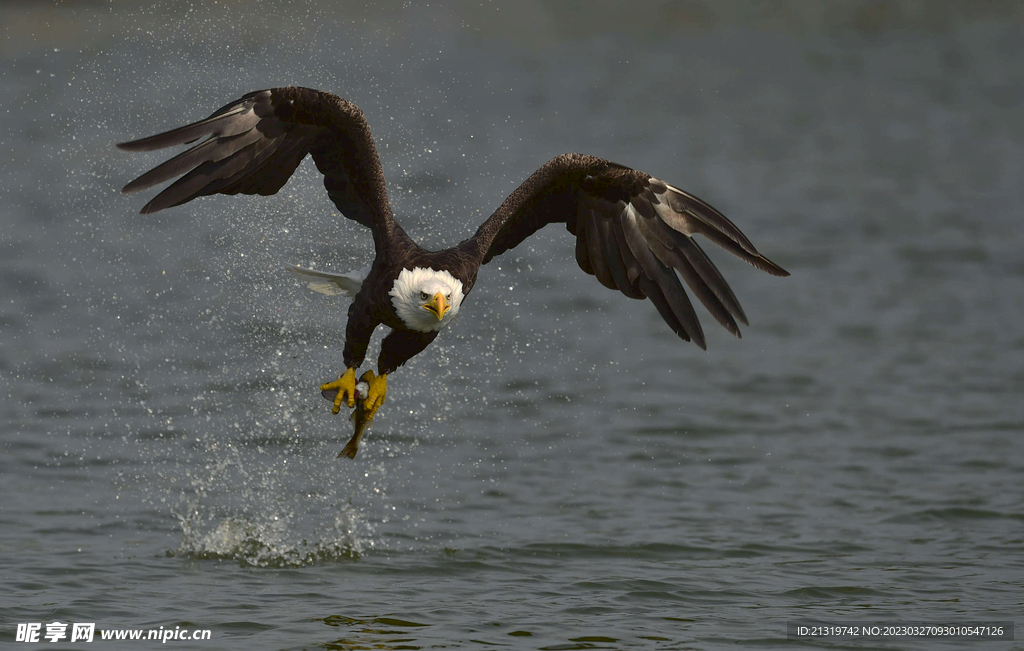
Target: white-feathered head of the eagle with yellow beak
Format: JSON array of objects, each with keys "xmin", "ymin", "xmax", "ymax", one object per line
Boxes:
[{"xmin": 389, "ymin": 267, "xmax": 463, "ymax": 333}]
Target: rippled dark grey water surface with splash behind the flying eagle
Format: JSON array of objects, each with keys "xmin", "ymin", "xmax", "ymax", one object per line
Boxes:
[{"xmin": 0, "ymin": 2, "xmax": 1024, "ymax": 649}]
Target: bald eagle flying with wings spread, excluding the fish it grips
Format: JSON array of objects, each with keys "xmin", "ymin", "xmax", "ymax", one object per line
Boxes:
[{"xmin": 117, "ymin": 87, "xmax": 788, "ymax": 420}]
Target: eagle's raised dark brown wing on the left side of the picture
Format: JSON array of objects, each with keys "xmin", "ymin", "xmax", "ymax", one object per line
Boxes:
[{"xmin": 118, "ymin": 87, "xmax": 393, "ymax": 245}]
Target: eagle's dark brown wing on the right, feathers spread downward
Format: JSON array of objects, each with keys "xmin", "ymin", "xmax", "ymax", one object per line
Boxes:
[{"xmin": 471, "ymin": 154, "xmax": 790, "ymax": 348}]
